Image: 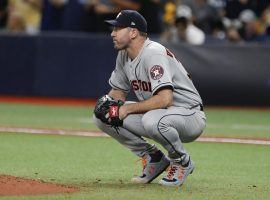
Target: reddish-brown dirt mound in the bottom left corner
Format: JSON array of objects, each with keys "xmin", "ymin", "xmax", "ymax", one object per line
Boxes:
[{"xmin": 0, "ymin": 174, "xmax": 78, "ymax": 196}]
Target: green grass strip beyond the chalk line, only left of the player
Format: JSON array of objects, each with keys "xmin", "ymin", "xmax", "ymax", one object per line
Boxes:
[{"xmin": 0, "ymin": 103, "xmax": 98, "ymax": 130}]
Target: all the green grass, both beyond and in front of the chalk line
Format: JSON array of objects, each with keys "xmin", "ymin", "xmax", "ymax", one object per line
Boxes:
[{"xmin": 0, "ymin": 103, "xmax": 270, "ymax": 200}]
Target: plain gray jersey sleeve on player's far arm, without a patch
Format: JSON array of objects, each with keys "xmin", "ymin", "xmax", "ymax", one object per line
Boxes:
[{"xmin": 109, "ymin": 52, "xmax": 130, "ymax": 93}]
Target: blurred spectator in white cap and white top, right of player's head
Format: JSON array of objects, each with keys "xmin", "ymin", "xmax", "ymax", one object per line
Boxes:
[{"xmin": 161, "ymin": 5, "xmax": 205, "ymax": 45}]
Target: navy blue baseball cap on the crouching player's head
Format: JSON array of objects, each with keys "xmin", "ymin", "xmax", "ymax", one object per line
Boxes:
[{"xmin": 105, "ymin": 10, "xmax": 147, "ymax": 33}]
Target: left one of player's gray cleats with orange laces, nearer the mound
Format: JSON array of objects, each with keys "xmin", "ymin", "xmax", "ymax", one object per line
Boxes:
[{"xmin": 131, "ymin": 151, "xmax": 170, "ymax": 183}]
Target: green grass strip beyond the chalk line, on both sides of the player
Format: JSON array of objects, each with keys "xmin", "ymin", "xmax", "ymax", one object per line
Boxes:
[{"xmin": 0, "ymin": 103, "xmax": 270, "ymax": 139}]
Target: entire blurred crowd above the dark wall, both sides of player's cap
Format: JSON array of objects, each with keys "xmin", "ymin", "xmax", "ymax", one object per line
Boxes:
[{"xmin": 0, "ymin": 0, "xmax": 270, "ymax": 45}]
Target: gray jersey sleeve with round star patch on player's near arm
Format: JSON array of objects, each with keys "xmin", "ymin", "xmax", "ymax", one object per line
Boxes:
[{"xmin": 146, "ymin": 54, "xmax": 174, "ymax": 95}]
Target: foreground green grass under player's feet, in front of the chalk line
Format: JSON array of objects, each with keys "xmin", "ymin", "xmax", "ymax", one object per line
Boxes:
[{"xmin": 0, "ymin": 133, "xmax": 270, "ymax": 200}]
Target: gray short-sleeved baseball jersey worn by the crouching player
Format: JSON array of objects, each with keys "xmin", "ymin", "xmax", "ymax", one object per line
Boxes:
[{"xmin": 109, "ymin": 39, "xmax": 202, "ymax": 108}]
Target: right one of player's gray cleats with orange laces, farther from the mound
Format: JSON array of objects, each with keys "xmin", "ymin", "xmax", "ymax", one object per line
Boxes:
[{"xmin": 159, "ymin": 160, "xmax": 195, "ymax": 186}]
